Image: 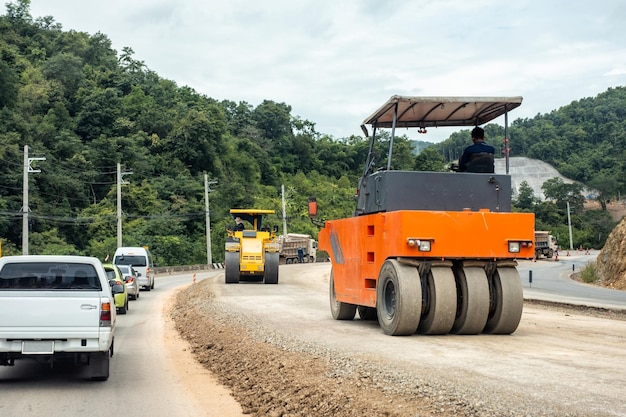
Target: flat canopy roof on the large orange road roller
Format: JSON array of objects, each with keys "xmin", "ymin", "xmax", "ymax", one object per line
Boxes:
[{"xmin": 361, "ymin": 96, "xmax": 522, "ymax": 136}]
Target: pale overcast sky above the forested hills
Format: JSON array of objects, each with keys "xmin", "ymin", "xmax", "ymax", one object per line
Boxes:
[{"xmin": 26, "ymin": 0, "xmax": 626, "ymax": 142}]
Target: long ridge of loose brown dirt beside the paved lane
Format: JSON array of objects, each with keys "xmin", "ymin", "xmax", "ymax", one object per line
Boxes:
[{"xmin": 171, "ymin": 283, "xmax": 444, "ymax": 417}]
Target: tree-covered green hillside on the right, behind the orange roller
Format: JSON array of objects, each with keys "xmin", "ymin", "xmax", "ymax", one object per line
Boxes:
[{"xmin": 434, "ymin": 87, "xmax": 626, "ymax": 248}]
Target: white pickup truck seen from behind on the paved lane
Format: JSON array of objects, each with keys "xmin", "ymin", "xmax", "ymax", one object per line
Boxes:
[{"xmin": 0, "ymin": 255, "xmax": 123, "ymax": 381}]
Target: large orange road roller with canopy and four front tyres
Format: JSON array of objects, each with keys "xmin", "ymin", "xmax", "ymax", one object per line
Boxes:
[{"xmin": 309, "ymin": 96, "xmax": 535, "ymax": 336}]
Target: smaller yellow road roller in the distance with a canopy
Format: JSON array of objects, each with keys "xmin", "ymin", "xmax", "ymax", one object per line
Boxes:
[{"xmin": 224, "ymin": 209, "xmax": 279, "ymax": 284}]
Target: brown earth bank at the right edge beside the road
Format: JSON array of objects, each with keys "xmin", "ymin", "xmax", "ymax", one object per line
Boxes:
[{"xmin": 596, "ymin": 219, "xmax": 626, "ymax": 290}]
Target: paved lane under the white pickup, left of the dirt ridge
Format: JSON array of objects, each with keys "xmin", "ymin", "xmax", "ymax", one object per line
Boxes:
[{"xmin": 0, "ymin": 271, "xmax": 230, "ymax": 417}]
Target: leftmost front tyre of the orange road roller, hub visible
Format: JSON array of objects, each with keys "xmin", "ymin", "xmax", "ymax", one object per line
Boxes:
[{"xmin": 376, "ymin": 259, "xmax": 422, "ymax": 336}]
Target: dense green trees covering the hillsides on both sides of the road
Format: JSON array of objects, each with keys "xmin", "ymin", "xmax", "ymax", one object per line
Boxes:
[{"xmin": 0, "ymin": 0, "xmax": 626, "ymax": 265}]
